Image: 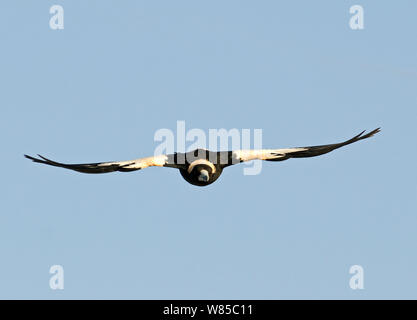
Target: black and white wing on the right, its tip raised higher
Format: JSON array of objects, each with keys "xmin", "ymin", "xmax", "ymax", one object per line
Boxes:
[{"xmin": 229, "ymin": 128, "xmax": 380, "ymax": 165}]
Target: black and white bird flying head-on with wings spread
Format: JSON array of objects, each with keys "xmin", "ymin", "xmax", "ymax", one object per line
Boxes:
[{"xmin": 25, "ymin": 128, "xmax": 380, "ymax": 186}]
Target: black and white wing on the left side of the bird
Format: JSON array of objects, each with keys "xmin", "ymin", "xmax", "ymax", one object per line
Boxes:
[{"xmin": 25, "ymin": 154, "xmax": 178, "ymax": 173}]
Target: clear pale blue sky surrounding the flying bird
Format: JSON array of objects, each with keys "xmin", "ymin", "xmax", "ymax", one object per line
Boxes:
[{"xmin": 0, "ymin": 0, "xmax": 417, "ymax": 299}]
